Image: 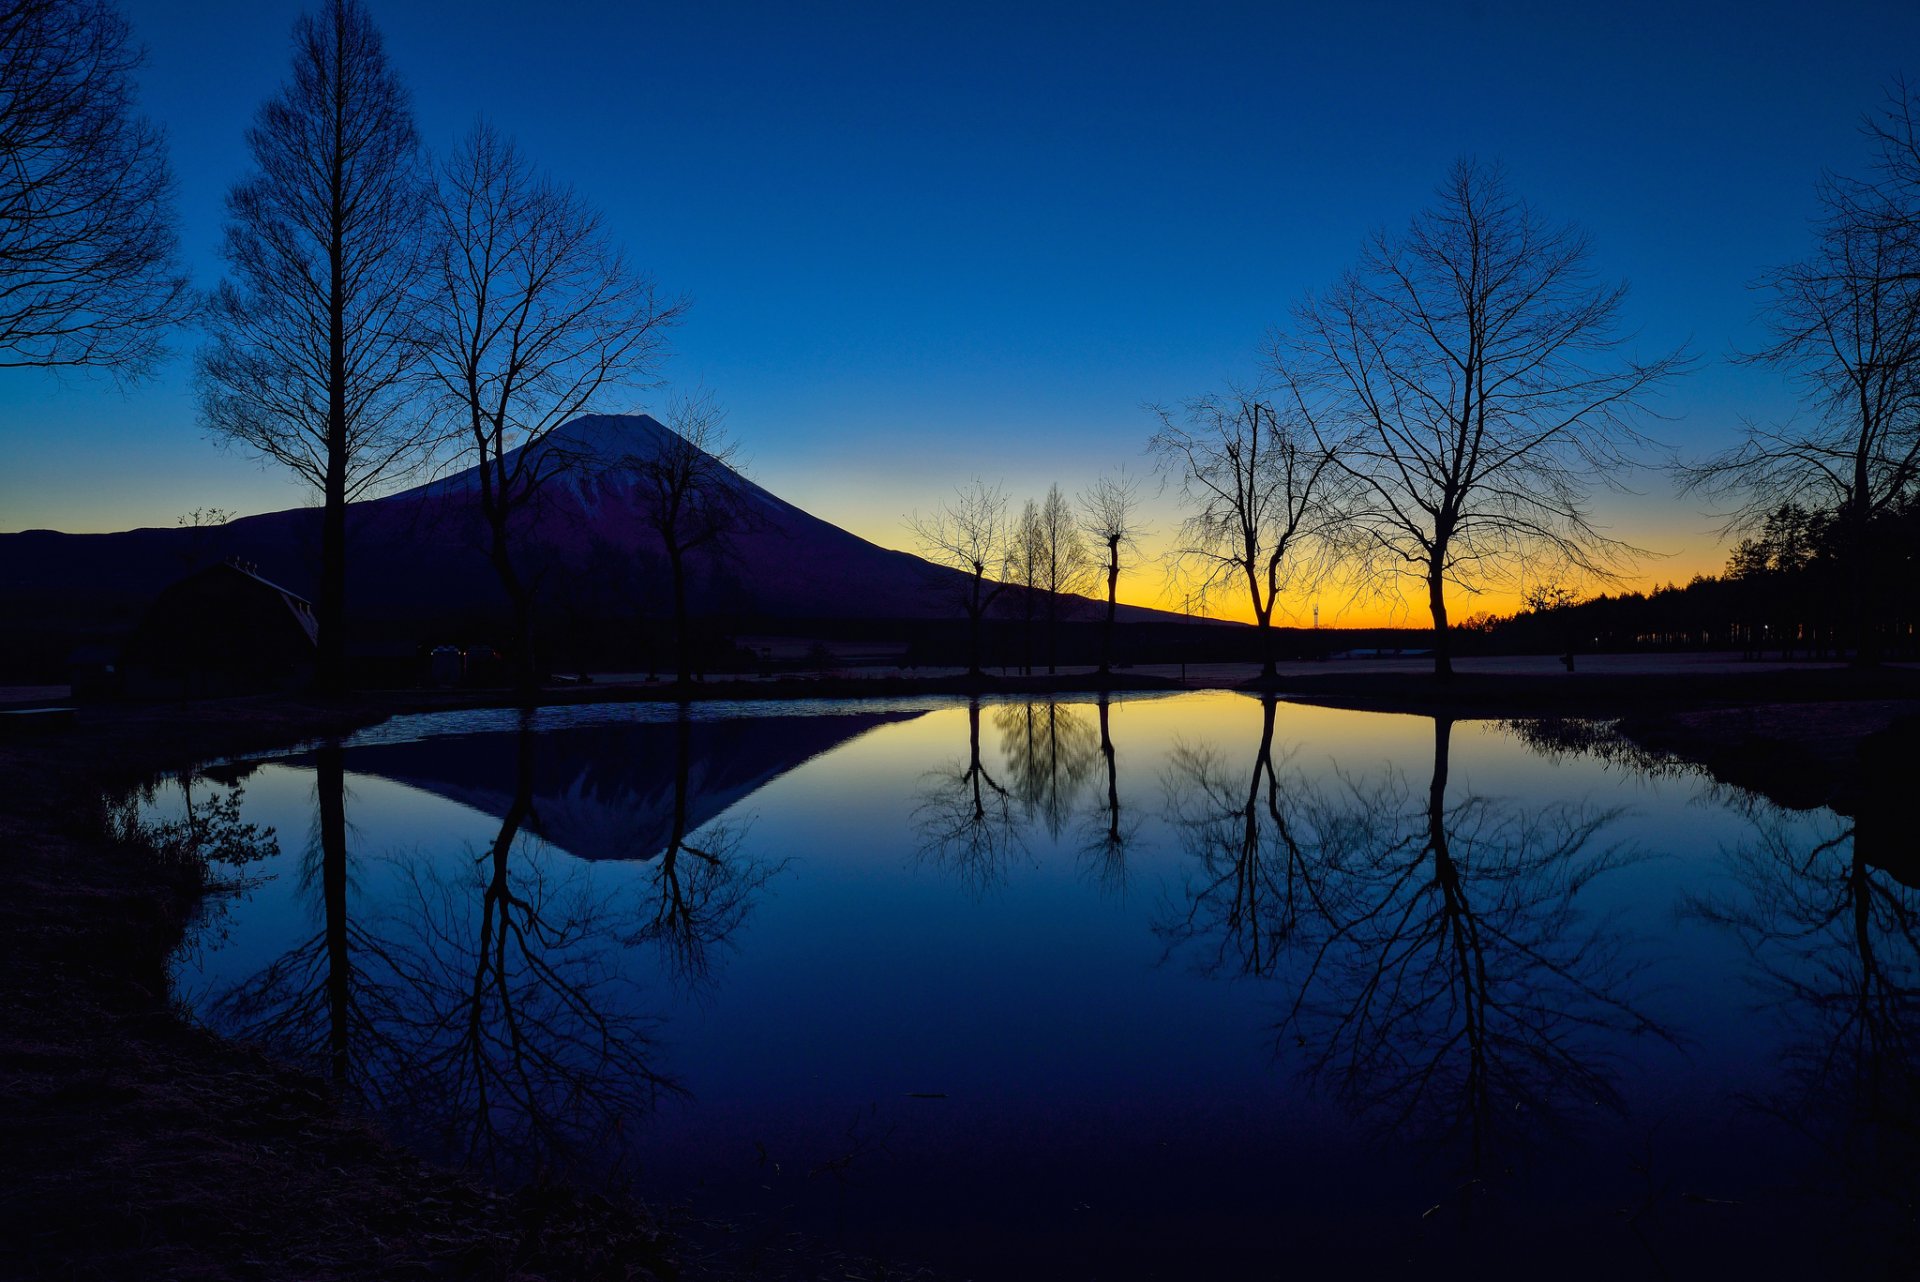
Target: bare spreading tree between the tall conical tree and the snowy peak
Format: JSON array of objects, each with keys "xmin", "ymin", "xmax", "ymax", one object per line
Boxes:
[{"xmin": 424, "ymin": 125, "xmax": 680, "ymax": 699}]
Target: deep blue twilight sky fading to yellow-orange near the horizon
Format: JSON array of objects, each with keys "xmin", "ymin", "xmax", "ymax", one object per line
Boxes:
[{"xmin": 0, "ymin": 0, "xmax": 1920, "ymax": 622}]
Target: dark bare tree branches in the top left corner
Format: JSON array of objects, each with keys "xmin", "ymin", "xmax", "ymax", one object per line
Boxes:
[{"xmin": 0, "ymin": 0, "xmax": 190, "ymax": 376}]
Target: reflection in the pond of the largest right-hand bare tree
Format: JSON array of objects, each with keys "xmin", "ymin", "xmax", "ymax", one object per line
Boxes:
[{"xmin": 1283, "ymin": 720, "xmax": 1670, "ymax": 1175}]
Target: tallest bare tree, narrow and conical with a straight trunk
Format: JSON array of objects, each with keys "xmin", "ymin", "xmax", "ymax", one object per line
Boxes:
[{"xmin": 200, "ymin": 0, "xmax": 428, "ymax": 693}]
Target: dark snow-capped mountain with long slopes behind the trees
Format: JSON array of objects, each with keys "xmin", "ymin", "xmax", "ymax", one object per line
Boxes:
[{"xmin": 0, "ymin": 415, "xmax": 1171, "ymax": 631}]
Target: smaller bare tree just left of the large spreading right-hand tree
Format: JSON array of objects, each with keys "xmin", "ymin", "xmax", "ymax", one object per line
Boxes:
[{"xmin": 1146, "ymin": 390, "xmax": 1334, "ymax": 679}]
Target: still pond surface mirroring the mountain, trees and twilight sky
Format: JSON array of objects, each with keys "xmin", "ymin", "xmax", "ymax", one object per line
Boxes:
[{"xmin": 144, "ymin": 693, "xmax": 1920, "ymax": 1278}]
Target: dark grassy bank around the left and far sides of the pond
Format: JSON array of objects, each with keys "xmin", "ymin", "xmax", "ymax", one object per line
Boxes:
[{"xmin": 0, "ymin": 670, "xmax": 1920, "ymax": 1280}]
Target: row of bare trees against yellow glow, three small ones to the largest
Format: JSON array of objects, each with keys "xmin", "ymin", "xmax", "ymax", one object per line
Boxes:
[{"xmin": 914, "ymin": 161, "xmax": 1686, "ymax": 677}]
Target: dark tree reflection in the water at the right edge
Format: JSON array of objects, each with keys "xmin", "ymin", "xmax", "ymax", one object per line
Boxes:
[{"xmin": 1688, "ymin": 760, "xmax": 1920, "ymax": 1267}]
